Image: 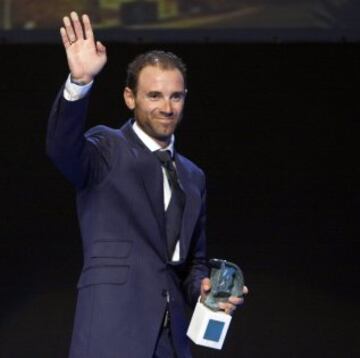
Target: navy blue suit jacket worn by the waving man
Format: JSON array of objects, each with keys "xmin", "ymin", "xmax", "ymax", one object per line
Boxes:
[{"xmin": 47, "ymin": 91, "xmax": 208, "ymax": 358}]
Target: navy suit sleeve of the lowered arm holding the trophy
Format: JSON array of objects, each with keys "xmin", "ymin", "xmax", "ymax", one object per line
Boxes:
[{"xmin": 184, "ymin": 175, "xmax": 209, "ymax": 306}]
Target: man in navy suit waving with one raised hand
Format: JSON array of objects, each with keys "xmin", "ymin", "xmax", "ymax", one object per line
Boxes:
[{"xmin": 47, "ymin": 12, "xmax": 242, "ymax": 358}]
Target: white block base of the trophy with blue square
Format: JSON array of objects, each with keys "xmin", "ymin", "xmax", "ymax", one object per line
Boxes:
[{"xmin": 186, "ymin": 302, "xmax": 232, "ymax": 349}]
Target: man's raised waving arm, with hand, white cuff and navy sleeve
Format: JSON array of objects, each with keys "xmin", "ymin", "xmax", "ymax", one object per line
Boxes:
[{"xmin": 47, "ymin": 12, "xmax": 106, "ymax": 187}]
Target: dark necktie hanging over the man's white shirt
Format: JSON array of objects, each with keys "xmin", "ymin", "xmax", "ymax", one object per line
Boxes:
[{"xmin": 154, "ymin": 150, "xmax": 185, "ymax": 258}]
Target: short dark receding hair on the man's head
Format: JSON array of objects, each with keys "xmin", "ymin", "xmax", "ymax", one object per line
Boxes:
[{"xmin": 126, "ymin": 50, "xmax": 186, "ymax": 93}]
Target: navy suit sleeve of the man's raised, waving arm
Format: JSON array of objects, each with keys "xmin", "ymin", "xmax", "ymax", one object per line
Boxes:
[{"xmin": 46, "ymin": 89, "xmax": 111, "ymax": 189}]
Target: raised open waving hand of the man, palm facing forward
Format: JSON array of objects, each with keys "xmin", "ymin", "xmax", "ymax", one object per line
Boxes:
[{"xmin": 60, "ymin": 12, "xmax": 107, "ymax": 84}]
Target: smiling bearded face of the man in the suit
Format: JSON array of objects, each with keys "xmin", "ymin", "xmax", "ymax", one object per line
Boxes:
[{"xmin": 124, "ymin": 66, "xmax": 186, "ymax": 147}]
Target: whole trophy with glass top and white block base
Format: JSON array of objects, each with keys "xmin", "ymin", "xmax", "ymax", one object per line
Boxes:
[{"xmin": 187, "ymin": 259, "xmax": 244, "ymax": 349}]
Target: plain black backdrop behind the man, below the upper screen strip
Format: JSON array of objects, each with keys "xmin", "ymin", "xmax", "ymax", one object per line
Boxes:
[{"xmin": 0, "ymin": 43, "xmax": 360, "ymax": 358}]
